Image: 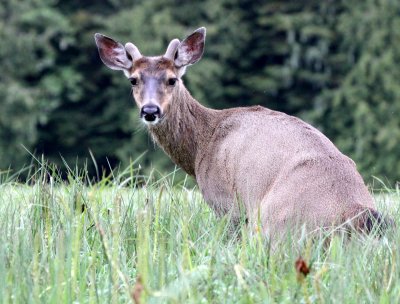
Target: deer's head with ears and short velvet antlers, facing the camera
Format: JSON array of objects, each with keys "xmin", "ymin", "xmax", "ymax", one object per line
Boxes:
[{"xmin": 95, "ymin": 28, "xmax": 205, "ymax": 125}]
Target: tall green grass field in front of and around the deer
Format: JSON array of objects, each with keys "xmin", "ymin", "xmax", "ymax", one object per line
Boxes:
[{"xmin": 0, "ymin": 165, "xmax": 400, "ymax": 303}]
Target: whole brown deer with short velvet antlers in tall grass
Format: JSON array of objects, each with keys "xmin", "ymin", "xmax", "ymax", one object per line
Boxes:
[{"xmin": 95, "ymin": 27, "xmax": 390, "ymax": 240}]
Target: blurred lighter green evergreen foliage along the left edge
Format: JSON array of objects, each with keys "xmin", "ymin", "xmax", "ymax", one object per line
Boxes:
[{"xmin": 0, "ymin": 0, "xmax": 72, "ymax": 169}]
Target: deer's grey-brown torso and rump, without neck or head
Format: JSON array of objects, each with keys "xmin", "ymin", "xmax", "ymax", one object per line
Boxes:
[{"xmin": 196, "ymin": 106, "xmax": 379, "ymax": 238}]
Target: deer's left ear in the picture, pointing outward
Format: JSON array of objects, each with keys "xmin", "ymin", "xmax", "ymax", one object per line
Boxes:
[{"xmin": 94, "ymin": 34, "xmax": 132, "ymax": 70}]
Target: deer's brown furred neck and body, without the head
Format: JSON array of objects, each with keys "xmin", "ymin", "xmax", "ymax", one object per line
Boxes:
[{"xmin": 149, "ymin": 78, "xmax": 384, "ymax": 240}]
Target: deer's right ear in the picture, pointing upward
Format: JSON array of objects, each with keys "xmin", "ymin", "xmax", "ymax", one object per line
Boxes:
[{"xmin": 174, "ymin": 27, "xmax": 206, "ymax": 68}]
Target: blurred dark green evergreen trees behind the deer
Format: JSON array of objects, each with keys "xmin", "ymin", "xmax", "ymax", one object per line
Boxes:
[{"xmin": 0, "ymin": 0, "xmax": 400, "ymax": 184}]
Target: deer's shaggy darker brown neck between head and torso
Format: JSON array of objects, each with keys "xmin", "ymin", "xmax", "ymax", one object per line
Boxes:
[{"xmin": 149, "ymin": 84, "xmax": 218, "ymax": 177}]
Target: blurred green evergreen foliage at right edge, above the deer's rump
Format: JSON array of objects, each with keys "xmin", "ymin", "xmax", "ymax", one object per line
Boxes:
[{"xmin": 314, "ymin": 0, "xmax": 400, "ymax": 181}]
